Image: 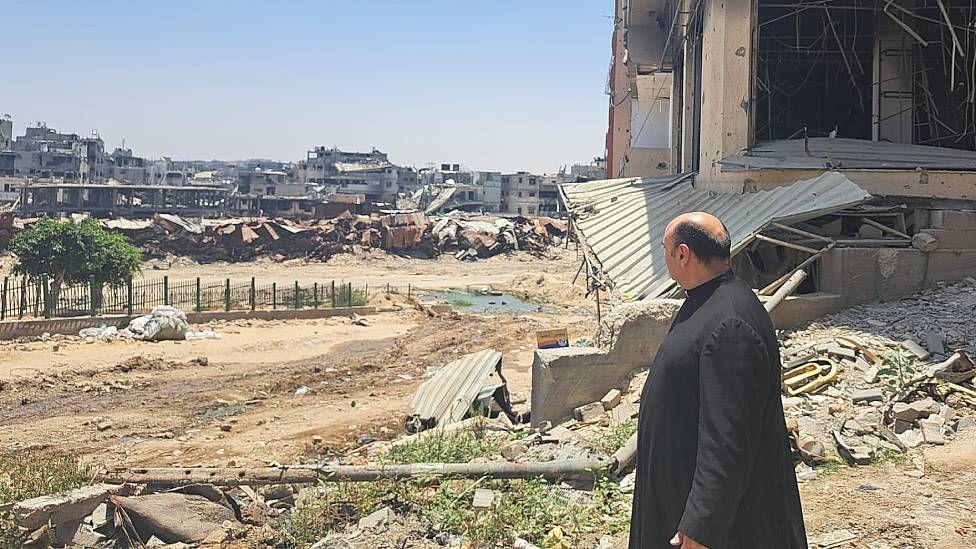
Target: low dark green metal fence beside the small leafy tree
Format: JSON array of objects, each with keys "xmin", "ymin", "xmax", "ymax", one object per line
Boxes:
[{"xmin": 0, "ymin": 276, "xmax": 415, "ymax": 320}]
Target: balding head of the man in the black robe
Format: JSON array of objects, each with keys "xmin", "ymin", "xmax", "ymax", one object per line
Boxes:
[{"xmin": 662, "ymin": 212, "xmax": 732, "ymax": 290}]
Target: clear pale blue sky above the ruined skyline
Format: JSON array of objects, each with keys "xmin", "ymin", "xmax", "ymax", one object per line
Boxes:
[{"xmin": 0, "ymin": 0, "xmax": 613, "ymax": 173}]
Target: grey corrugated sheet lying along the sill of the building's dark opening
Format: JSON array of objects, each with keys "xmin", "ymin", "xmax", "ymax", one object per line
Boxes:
[{"xmin": 722, "ymin": 137, "xmax": 976, "ymax": 170}]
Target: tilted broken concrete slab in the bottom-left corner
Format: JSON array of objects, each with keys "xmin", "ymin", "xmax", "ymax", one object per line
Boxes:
[{"xmin": 13, "ymin": 484, "xmax": 136, "ymax": 530}]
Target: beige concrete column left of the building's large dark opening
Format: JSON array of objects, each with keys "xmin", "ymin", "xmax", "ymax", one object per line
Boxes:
[{"xmin": 699, "ymin": 0, "xmax": 754, "ymax": 190}]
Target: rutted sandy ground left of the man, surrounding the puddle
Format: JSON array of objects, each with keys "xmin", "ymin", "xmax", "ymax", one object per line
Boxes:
[{"xmin": 0, "ymin": 250, "xmax": 595, "ymax": 466}]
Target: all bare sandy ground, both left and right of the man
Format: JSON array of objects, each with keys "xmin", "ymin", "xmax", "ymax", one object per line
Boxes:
[{"xmin": 0, "ymin": 249, "xmax": 976, "ymax": 549}]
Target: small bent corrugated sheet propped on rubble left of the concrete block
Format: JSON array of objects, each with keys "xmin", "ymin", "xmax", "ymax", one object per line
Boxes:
[{"xmin": 410, "ymin": 349, "xmax": 502, "ymax": 425}]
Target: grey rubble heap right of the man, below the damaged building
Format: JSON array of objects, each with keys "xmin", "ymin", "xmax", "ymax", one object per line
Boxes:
[{"xmin": 781, "ymin": 278, "xmax": 976, "ymax": 480}]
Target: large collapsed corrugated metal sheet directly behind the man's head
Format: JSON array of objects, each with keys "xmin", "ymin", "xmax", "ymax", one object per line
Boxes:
[{"xmin": 562, "ymin": 172, "xmax": 871, "ymax": 299}]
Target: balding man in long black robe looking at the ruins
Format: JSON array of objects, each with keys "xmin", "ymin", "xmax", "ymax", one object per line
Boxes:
[{"xmin": 630, "ymin": 212, "xmax": 807, "ymax": 549}]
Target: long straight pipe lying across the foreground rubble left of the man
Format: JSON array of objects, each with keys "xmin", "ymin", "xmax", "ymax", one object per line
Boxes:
[{"xmin": 100, "ymin": 457, "xmax": 616, "ymax": 487}]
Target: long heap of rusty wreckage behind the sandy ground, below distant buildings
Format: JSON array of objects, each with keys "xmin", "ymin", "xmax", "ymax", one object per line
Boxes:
[{"xmin": 105, "ymin": 212, "xmax": 567, "ymax": 261}]
